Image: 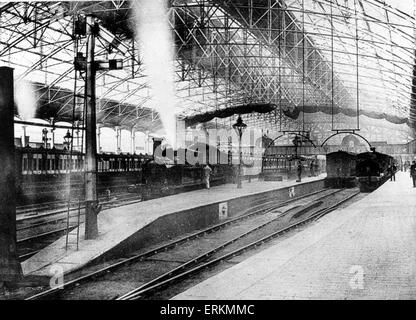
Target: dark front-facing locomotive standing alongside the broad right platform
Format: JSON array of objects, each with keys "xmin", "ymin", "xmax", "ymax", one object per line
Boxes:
[{"xmin": 356, "ymin": 151, "xmax": 394, "ymax": 192}]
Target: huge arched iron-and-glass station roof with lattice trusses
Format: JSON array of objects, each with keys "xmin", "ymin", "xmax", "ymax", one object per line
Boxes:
[{"xmin": 0, "ymin": 0, "xmax": 416, "ymax": 131}]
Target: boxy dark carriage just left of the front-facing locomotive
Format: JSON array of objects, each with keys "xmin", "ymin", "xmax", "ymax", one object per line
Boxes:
[{"xmin": 325, "ymin": 151, "xmax": 357, "ymax": 188}]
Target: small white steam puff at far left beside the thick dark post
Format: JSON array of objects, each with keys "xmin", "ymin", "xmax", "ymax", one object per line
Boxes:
[{"xmin": 14, "ymin": 80, "xmax": 37, "ymax": 120}]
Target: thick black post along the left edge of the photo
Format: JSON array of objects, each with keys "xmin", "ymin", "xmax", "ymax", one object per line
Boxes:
[{"xmin": 0, "ymin": 67, "xmax": 22, "ymax": 284}]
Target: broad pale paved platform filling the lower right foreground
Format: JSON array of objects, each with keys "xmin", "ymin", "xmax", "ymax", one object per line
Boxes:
[{"xmin": 174, "ymin": 172, "xmax": 416, "ymax": 299}]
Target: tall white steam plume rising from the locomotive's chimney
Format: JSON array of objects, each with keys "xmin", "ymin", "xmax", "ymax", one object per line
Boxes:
[{"xmin": 133, "ymin": 0, "xmax": 176, "ymax": 147}]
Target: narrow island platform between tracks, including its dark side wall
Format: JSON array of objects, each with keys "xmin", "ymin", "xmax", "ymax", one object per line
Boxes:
[{"xmin": 22, "ymin": 174, "xmax": 325, "ymax": 277}]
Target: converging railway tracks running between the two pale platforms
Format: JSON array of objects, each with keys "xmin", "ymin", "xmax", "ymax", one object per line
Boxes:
[{"xmin": 24, "ymin": 190, "xmax": 359, "ymax": 300}]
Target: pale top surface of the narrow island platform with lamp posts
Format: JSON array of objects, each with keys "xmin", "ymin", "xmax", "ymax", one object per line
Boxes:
[{"xmin": 22, "ymin": 174, "xmax": 326, "ymax": 276}]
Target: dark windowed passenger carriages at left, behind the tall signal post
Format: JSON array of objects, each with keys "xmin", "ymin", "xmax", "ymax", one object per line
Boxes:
[{"xmin": 15, "ymin": 147, "xmax": 151, "ymax": 204}]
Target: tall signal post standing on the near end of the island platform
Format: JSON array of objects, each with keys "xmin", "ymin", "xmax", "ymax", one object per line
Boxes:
[{"xmin": 85, "ymin": 16, "xmax": 98, "ymax": 239}]
